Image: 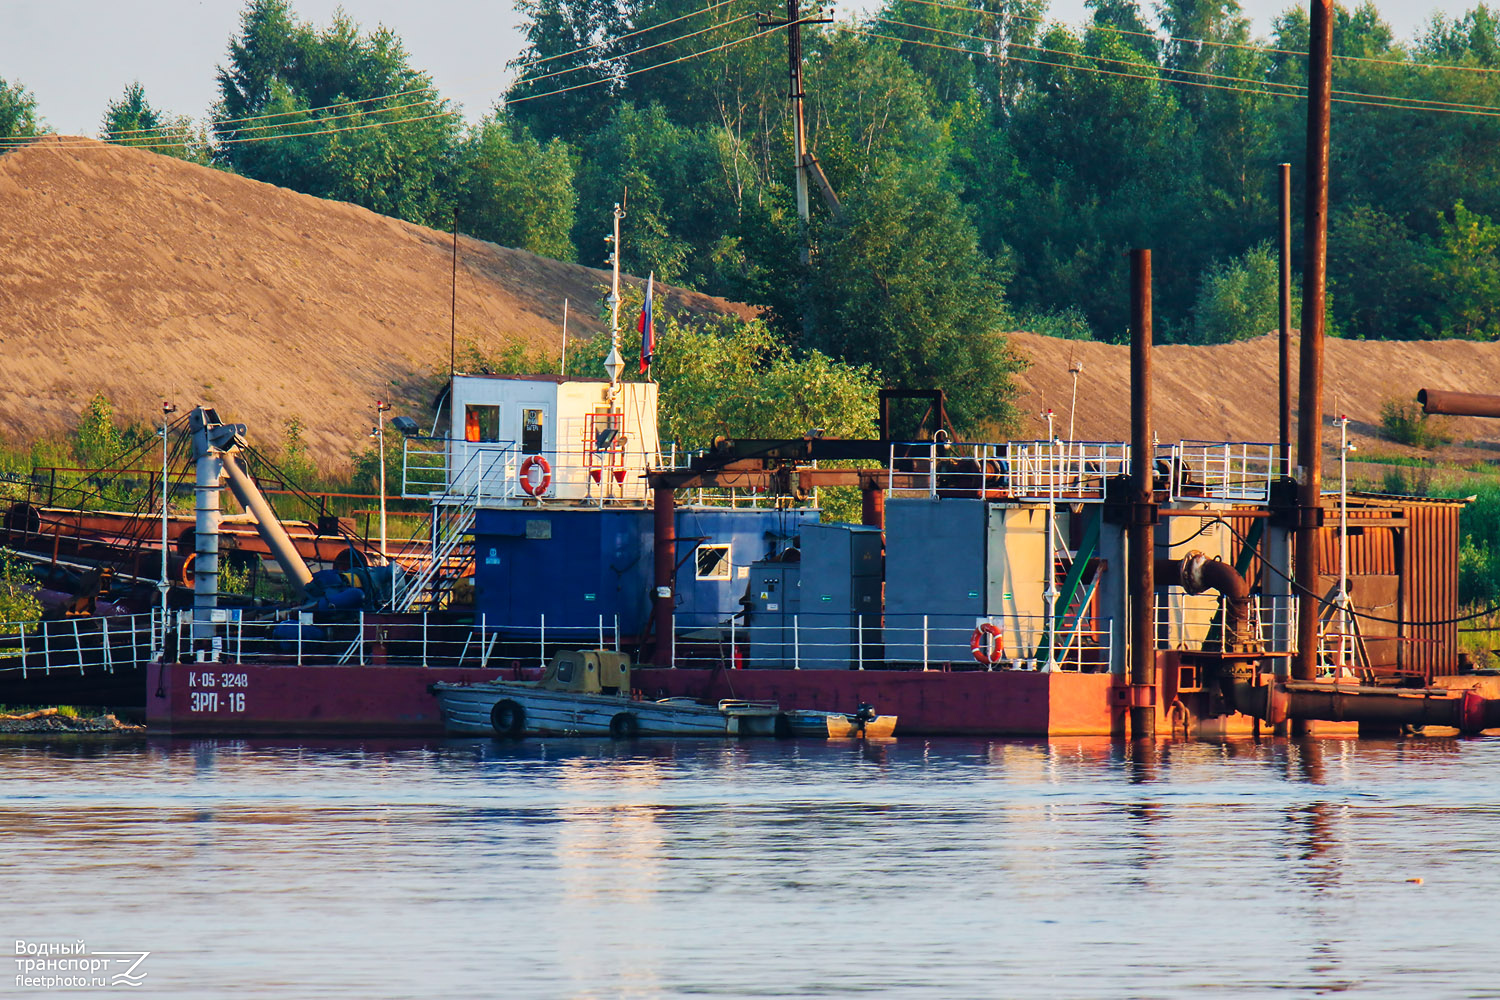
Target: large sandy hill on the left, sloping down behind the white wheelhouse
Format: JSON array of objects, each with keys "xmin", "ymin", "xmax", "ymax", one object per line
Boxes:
[{"xmin": 0, "ymin": 139, "xmax": 749, "ymax": 463}]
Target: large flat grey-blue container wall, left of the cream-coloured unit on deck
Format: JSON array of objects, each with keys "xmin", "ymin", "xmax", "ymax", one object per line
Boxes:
[{"xmin": 882, "ymin": 499, "xmax": 989, "ymax": 664}]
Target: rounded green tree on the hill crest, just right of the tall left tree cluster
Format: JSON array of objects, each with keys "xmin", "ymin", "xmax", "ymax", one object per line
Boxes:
[{"xmin": 458, "ymin": 114, "xmax": 578, "ymax": 261}]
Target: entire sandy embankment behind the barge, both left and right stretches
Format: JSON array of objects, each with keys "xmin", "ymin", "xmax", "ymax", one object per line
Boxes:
[{"xmin": 0, "ymin": 139, "xmax": 1500, "ymax": 476}]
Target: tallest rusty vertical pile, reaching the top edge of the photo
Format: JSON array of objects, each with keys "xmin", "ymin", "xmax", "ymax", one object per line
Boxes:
[{"xmin": 1292, "ymin": 0, "xmax": 1334, "ymax": 733}]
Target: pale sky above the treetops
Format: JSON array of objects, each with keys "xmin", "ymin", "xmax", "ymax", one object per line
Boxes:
[{"xmin": 0, "ymin": 0, "xmax": 1478, "ymax": 135}]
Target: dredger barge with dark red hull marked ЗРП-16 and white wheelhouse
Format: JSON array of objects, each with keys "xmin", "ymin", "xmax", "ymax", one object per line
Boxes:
[{"xmin": 3, "ymin": 262, "xmax": 1500, "ymax": 738}]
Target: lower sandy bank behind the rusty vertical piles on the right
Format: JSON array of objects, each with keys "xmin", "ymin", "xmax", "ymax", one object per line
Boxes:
[{"xmin": 1011, "ymin": 333, "xmax": 1500, "ymax": 470}]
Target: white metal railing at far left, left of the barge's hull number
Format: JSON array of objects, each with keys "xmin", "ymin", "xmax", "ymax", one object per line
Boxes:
[{"xmin": 0, "ymin": 613, "xmax": 161, "ymax": 679}]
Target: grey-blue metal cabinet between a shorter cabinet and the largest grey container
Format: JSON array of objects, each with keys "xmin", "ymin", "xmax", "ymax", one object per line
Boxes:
[{"xmin": 797, "ymin": 525, "xmax": 884, "ymax": 670}]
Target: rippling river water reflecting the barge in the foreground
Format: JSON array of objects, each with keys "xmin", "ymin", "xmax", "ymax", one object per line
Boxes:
[{"xmin": 0, "ymin": 738, "xmax": 1500, "ymax": 999}]
